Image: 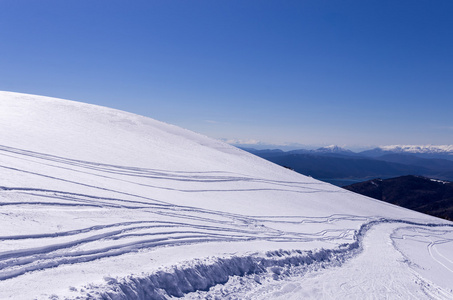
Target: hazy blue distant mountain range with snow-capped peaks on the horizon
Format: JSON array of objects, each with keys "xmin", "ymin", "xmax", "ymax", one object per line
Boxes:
[{"xmin": 243, "ymin": 146, "xmax": 453, "ymax": 186}]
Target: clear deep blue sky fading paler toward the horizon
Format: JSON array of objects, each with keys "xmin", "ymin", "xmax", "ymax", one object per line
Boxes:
[{"xmin": 0, "ymin": 0, "xmax": 453, "ymax": 148}]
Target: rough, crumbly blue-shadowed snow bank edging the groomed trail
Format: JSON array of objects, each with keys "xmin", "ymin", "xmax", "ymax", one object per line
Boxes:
[{"xmin": 79, "ymin": 218, "xmax": 453, "ymax": 300}]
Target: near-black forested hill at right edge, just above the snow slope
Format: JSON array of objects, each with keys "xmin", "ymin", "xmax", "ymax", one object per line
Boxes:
[{"xmin": 344, "ymin": 176, "xmax": 453, "ymax": 220}]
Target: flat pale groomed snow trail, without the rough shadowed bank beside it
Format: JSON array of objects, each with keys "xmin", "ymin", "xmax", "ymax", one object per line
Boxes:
[{"xmin": 193, "ymin": 222, "xmax": 453, "ymax": 300}]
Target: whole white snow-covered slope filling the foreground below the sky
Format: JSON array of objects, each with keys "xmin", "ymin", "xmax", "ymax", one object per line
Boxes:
[{"xmin": 0, "ymin": 92, "xmax": 453, "ymax": 299}]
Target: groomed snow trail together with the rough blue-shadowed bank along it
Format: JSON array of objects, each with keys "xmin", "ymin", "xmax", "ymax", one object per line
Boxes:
[{"xmin": 78, "ymin": 219, "xmax": 453, "ymax": 300}]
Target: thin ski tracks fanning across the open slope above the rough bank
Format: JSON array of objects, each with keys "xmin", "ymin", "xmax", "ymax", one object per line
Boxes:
[{"xmin": 0, "ymin": 146, "xmax": 353, "ymax": 280}]
